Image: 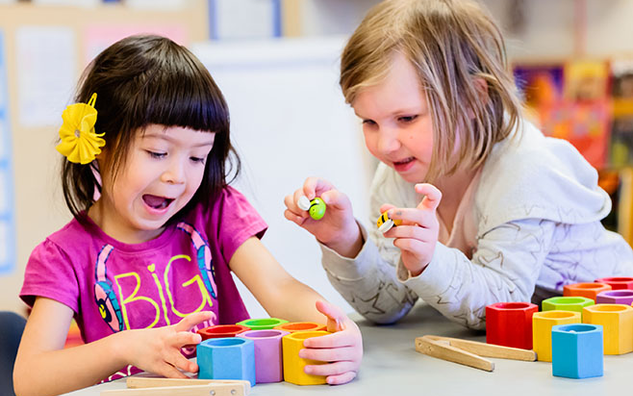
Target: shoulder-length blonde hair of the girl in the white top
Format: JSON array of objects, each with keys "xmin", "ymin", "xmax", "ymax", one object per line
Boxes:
[{"xmin": 339, "ymin": 0, "xmax": 521, "ymax": 181}]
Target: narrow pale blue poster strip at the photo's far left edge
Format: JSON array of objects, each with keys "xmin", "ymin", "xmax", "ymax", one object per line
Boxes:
[{"xmin": 0, "ymin": 31, "xmax": 15, "ymax": 275}]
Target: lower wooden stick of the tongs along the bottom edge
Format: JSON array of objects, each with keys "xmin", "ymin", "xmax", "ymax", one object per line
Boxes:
[{"xmin": 101, "ymin": 384, "xmax": 246, "ymax": 396}]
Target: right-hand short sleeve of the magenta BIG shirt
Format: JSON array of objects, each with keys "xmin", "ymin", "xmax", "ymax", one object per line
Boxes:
[{"xmin": 213, "ymin": 187, "xmax": 268, "ymax": 263}]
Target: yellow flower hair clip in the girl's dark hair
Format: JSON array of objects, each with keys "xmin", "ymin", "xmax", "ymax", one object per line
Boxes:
[{"xmin": 55, "ymin": 93, "xmax": 105, "ymax": 165}]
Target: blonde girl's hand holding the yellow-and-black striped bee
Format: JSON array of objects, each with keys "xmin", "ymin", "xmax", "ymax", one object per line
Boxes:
[{"xmin": 380, "ymin": 183, "xmax": 442, "ymax": 276}]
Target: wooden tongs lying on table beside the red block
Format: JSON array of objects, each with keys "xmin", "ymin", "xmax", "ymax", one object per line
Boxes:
[{"xmin": 415, "ymin": 335, "xmax": 536, "ymax": 371}]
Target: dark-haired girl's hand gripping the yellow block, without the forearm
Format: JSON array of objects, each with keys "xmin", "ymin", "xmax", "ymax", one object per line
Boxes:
[{"xmin": 299, "ymin": 301, "xmax": 363, "ymax": 385}]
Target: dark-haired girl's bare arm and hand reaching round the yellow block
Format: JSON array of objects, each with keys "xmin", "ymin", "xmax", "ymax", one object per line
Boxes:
[{"xmin": 229, "ymin": 237, "xmax": 363, "ymax": 384}]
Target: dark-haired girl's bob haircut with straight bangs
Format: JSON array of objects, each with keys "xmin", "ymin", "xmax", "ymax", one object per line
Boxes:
[{"xmin": 62, "ymin": 35, "xmax": 240, "ymax": 222}]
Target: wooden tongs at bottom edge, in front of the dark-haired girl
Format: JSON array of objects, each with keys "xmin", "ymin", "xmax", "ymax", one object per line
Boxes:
[{"xmin": 101, "ymin": 377, "xmax": 251, "ymax": 396}]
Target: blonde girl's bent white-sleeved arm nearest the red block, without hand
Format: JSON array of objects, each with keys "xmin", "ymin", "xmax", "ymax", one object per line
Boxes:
[{"xmin": 404, "ymin": 219, "xmax": 552, "ymax": 329}]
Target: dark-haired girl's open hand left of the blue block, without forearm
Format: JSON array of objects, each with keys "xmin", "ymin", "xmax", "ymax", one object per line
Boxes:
[{"xmin": 117, "ymin": 311, "xmax": 212, "ymax": 378}]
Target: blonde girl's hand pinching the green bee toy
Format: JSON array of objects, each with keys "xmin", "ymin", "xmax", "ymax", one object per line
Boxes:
[{"xmin": 284, "ymin": 177, "xmax": 363, "ymax": 257}]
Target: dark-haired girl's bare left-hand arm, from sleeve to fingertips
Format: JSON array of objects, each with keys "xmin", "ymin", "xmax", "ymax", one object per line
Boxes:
[{"xmin": 13, "ymin": 297, "xmax": 210, "ymax": 396}]
